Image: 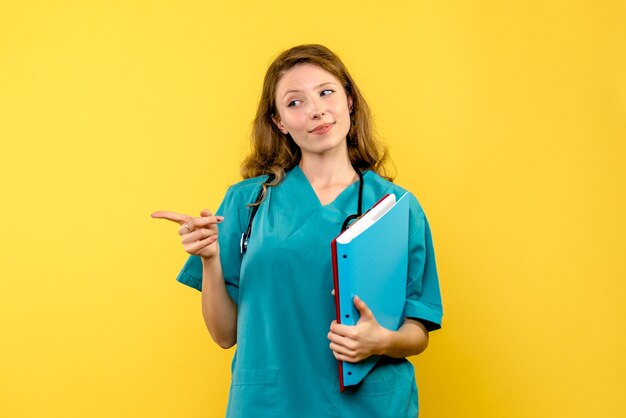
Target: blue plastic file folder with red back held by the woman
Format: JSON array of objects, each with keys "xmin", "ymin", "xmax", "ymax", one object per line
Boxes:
[{"xmin": 331, "ymin": 193, "xmax": 409, "ymax": 392}]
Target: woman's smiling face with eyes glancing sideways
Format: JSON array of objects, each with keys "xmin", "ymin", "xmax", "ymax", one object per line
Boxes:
[{"xmin": 273, "ymin": 64, "xmax": 352, "ymax": 158}]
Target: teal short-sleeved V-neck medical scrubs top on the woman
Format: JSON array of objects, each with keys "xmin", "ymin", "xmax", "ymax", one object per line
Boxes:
[{"xmin": 177, "ymin": 166, "xmax": 443, "ymax": 418}]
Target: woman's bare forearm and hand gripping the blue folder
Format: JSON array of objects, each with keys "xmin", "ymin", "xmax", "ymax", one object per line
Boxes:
[{"xmin": 328, "ymin": 297, "xmax": 428, "ymax": 363}]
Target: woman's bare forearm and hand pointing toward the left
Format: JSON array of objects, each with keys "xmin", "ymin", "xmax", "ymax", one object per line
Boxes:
[{"xmin": 152, "ymin": 209, "xmax": 237, "ymax": 348}]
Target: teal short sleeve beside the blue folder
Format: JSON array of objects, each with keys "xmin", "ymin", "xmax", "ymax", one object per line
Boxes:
[{"xmin": 404, "ymin": 195, "xmax": 443, "ymax": 331}]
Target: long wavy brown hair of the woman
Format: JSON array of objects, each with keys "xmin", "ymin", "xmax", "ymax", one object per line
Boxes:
[{"xmin": 241, "ymin": 44, "xmax": 392, "ymax": 199}]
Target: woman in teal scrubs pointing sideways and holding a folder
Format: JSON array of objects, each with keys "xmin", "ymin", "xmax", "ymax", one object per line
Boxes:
[{"xmin": 152, "ymin": 45, "xmax": 442, "ymax": 418}]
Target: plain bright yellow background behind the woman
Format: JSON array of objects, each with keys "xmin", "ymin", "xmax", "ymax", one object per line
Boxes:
[{"xmin": 0, "ymin": 0, "xmax": 626, "ymax": 418}]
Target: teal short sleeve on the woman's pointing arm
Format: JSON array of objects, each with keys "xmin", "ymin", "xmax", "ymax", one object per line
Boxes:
[{"xmin": 176, "ymin": 183, "xmax": 249, "ymax": 303}]
